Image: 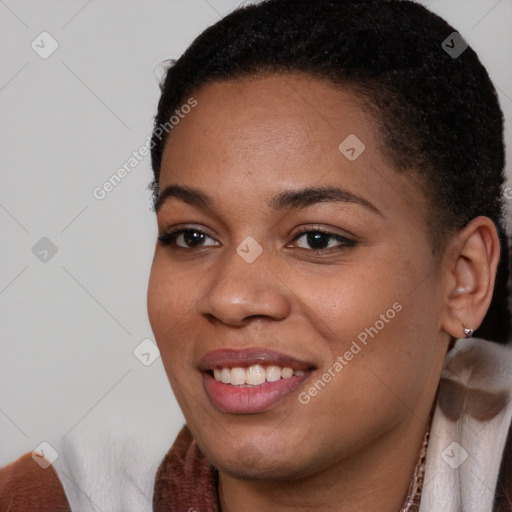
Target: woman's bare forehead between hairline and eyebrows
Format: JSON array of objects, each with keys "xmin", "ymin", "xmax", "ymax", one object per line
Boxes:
[{"xmin": 160, "ymin": 74, "xmax": 424, "ymax": 225}]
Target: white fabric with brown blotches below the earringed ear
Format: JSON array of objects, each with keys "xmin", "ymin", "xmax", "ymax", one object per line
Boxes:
[{"xmin": 420, "ymin": 338, "xmax": 512, "ymax": 512}]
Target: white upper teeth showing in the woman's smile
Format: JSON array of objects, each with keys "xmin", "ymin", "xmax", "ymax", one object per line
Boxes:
[{"xmin": 213, "ymin": 364, "xmax": 305, "ymax": 386}]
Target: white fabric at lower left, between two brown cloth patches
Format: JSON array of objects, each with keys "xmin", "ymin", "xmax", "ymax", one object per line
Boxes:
[{"xmin": 53, "ymin": 412, "xmax": 164, "ymax": 512}]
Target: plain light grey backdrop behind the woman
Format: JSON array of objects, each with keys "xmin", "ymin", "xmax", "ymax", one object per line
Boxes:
[{"xmin": 0, "ymin": 0, "xmax": 512, "ymax": 465}]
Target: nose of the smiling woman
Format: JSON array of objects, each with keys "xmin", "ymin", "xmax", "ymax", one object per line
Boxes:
[{"xmin": 199, "ymin": 242, "xmax": 291, "ymax": 326}]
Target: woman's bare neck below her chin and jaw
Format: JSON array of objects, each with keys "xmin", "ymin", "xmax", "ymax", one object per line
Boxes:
[{"xmin": 219, "ymin": 414, "xmax": 427, "ymax": 512}]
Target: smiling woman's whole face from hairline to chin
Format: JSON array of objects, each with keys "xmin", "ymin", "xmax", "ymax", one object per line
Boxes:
[{"xmin": 148, "ymin": 74, "xmax": 448, "ymax": 478}]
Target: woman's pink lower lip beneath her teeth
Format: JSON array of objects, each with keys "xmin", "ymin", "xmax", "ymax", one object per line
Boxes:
[{"xmin": 203, "ymin": 371, "xmax": 311, "ymax": 414}]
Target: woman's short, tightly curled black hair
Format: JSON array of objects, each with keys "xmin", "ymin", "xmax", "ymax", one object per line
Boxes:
[{"xmin": 151, "ymin": 0, "xmax": 510, "ymax": 343}]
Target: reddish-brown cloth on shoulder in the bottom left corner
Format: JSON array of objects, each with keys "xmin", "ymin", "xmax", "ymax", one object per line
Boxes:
[{"xmin": 0, "ymin": 453, "xmax": 71, "ymax": 512}]
